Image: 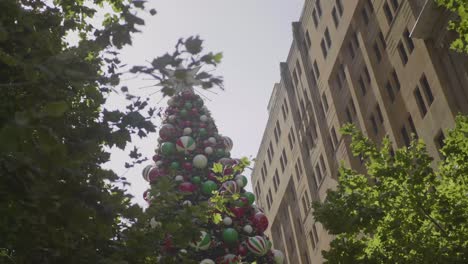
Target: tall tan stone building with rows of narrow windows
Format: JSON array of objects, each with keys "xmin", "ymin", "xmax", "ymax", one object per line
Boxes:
[{"xmin": 252, "ymin": 0, "xmax": 468, "ymax": 264}]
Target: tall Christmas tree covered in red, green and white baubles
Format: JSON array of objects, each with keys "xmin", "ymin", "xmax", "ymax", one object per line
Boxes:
[{"xmin": 138, "ymin": 39, "xmax": 284, "ymax": 264}]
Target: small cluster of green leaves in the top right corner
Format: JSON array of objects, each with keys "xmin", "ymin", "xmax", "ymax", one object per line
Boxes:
[{"xmin": 436, "ymin": 0, "xmax": 468, "ymax": 53}]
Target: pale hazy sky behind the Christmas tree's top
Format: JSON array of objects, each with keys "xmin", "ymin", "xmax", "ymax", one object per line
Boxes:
[{"xmin": 105, "ymin": 0, "xmax": 304, "ymax": 205}]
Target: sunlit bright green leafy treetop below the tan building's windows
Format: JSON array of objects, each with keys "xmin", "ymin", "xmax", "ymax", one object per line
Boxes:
[{"xmin": 313, "ymin": 117, "xmax": 468, "ymax": 263}]
